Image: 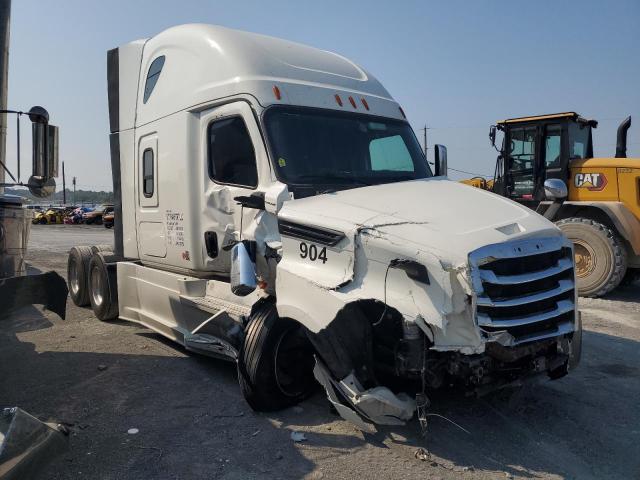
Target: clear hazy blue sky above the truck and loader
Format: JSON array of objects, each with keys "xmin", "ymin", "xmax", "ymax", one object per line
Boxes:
[{"xmin": 8, "ymin": 0, "xmax": 640, "ymax": 189}]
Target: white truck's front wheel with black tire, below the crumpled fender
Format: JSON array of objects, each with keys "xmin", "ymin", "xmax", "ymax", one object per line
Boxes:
[{"xmin": 238, "ymin": 300, "xmax": 315, "ymax": 412}]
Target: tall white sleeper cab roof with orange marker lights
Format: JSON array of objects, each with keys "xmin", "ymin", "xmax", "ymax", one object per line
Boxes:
[{"xmin": 111, "ymin": 24, "xmax": 404, "ymax": 132}]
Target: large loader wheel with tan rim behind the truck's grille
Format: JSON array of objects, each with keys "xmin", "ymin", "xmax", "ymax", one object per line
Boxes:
[{"xmin": 556, "ymin": 217, "xmax": 627, "ymax": 298}]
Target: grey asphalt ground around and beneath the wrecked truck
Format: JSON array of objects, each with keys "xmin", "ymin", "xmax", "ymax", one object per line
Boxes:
[{"xmin": 0, "ymin": 225, "xmax": 640, "ymax": 480}]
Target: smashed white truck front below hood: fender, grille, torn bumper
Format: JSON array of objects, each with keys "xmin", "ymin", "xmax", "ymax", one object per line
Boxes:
[{"xmin": 277, "ymin": 197, "xmax": 581, "ymax": 431}]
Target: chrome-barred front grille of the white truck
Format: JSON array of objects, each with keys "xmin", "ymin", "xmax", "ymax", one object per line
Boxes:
[{"xmin": 469, "ymin": 237, "xmax": 575, "ymax": 344}]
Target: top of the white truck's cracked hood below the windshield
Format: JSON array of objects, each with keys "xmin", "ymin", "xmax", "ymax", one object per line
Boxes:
[{"xmin": 278, "ymin": 177, "xmax": 560, "ymax": 262}]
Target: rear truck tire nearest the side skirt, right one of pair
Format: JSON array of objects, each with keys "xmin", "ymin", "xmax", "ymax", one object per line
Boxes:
[{"xmin": 89, "ymin": 252, "xmax": 118, "ymax": 321}]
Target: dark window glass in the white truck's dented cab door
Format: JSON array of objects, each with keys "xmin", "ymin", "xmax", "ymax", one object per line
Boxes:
[{"xmin": 207, "ymin": 117, "xmax": 258, "ymax": 188}]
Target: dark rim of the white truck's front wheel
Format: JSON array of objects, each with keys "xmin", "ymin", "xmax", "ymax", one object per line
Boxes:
[{"xmin": 274, "ymin": 328, "xmax": 313, "ymax": 397}]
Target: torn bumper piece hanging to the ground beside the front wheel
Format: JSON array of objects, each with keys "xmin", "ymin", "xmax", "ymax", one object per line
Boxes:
[{"xmin": 313, "ymin": 358, "xmax": 416, "ymax": 433}]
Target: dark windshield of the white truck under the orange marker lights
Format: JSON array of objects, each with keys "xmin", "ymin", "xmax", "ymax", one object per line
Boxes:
[{"xmin": 265, "ymin": 107, "xmax": 431, "ymax": 188}]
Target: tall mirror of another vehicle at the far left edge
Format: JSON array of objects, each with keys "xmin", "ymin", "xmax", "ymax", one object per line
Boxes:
[{"xmin": 28, "ymin": 106, "xmax": 59, "ymax": 197}]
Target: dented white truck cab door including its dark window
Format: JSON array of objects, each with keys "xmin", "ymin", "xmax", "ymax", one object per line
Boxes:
[{"xmin": 200, "ymin": 102, "xmax": 270, "ymax": 274}]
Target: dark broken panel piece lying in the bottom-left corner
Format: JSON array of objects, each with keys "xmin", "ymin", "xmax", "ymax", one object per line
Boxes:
[{"xmin": 0, "ymin": 407, "xmax": 67, "ymax": 480}]
